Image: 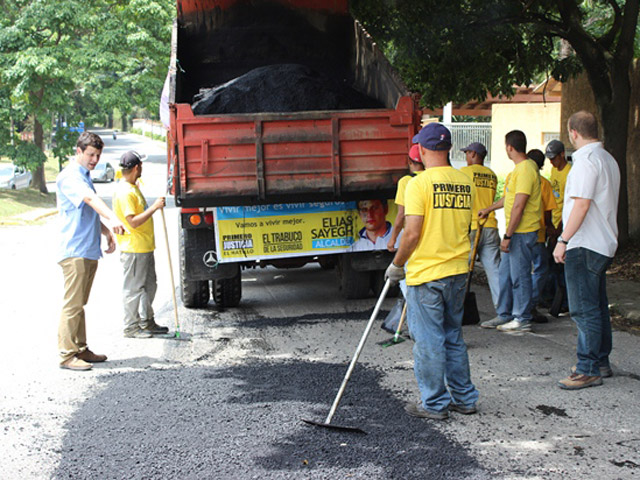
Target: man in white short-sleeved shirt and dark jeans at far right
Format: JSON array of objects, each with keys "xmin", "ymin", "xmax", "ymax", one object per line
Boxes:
[{"xmin": 553, "ymin": 111, "xmax": 620, "ymax": 390}]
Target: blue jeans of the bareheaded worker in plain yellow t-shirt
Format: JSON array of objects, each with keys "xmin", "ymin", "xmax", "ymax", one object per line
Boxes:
[{"xmin": 497, "ymin": 232, "xmax": 538, "ymax": 322}]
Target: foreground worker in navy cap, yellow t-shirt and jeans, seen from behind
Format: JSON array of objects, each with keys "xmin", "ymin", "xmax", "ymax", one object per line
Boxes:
[{"xmin": 385, "ymin": 123, "xmax": 478, "ymax": 420}]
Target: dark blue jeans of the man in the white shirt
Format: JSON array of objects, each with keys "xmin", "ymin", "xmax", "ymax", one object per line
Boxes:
[{"xmin": 564, "ymin": 248, "xmax": 613, "ymax": 377}]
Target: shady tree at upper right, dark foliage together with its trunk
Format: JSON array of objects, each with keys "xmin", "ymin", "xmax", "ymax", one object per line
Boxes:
[{"xmin": 351, "ymin": 0, "xmax": 640, "ymax": 241}]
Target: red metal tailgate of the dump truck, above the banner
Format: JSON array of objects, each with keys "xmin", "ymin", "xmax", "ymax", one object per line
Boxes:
[{"xmin": 170, "ymin": 96, "xmax": 419, "ymax": 207}]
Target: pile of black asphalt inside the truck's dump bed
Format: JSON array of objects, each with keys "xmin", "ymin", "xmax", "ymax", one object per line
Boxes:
[{"xmin": 192, "ymin": 64, "xmax": 382, "ymax": 115}]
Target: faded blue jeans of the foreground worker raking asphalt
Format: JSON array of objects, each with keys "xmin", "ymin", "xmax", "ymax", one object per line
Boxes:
[{"xmin": 407, "ymin": 275, "xmax": 478, "ymax": 412}]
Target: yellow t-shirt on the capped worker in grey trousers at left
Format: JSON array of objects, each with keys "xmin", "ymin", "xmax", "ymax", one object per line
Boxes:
[{"xmin": 113, "ymin": 180, "xmax": 156, "ymax": 253}]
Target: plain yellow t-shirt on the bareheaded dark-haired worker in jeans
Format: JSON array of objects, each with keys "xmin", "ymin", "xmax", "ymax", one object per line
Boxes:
[{"xmin": 504, "ymin": 159, "xmax": 542, "ymax": 233}]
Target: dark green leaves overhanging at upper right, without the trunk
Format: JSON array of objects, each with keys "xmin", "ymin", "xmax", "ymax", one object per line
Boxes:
[{"xmin": 351, "ymin": 0, "xmax": 637, "ymax": 107}]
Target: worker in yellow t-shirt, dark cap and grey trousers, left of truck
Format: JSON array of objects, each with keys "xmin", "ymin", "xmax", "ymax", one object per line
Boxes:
[{"xmin": 113, "ymin": 151, "xmax": 169, "ymax": 338}]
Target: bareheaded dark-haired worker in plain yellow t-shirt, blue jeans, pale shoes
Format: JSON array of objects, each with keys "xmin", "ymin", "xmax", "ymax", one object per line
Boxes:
[{"xmin": 478, "ymin": 130, "xmax": 542, "ymax": 332}]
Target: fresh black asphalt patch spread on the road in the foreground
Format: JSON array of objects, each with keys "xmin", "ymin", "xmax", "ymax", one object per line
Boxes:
[{"xmin": 54, "ymin": 361, "xmax": 491, "ymax": 480}]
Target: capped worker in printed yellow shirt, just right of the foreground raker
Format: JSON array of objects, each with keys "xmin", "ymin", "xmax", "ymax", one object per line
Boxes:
[{"xmin": 460, "ymin": 142, "xmax": 500, "ymax": 308}]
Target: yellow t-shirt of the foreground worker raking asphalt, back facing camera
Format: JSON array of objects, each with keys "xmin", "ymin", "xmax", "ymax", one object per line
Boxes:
[{"xmin": 405, "ymin": 167, "xmax": 474, "ymax": 285}]
